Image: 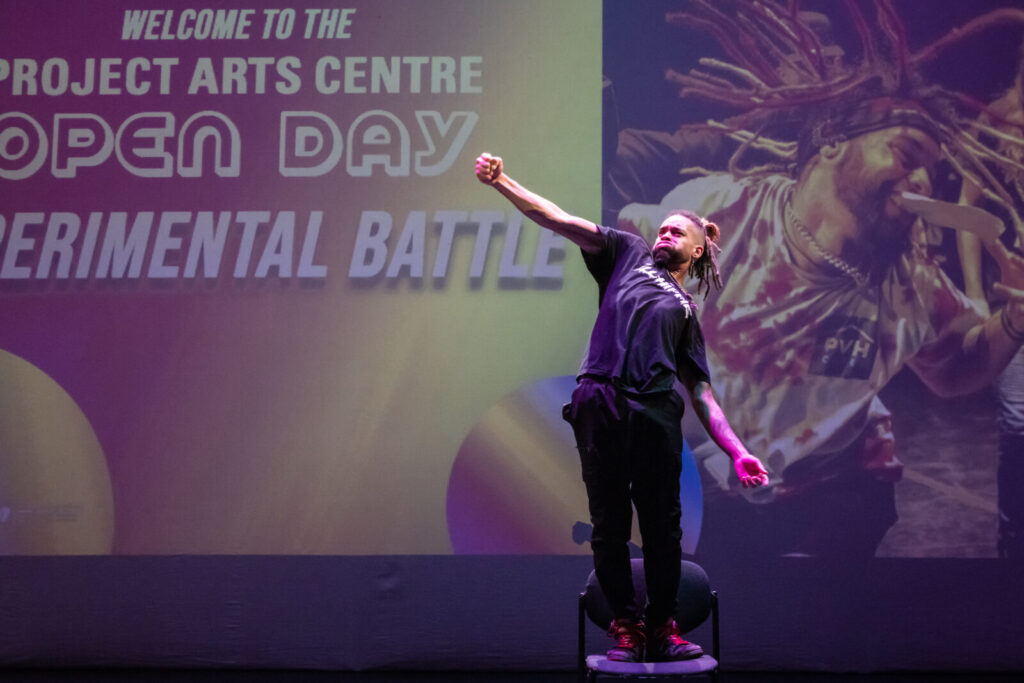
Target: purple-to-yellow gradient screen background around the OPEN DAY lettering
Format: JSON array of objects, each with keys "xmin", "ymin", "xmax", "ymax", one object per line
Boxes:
[{"xmin": 0, "ymin": 0, "xmax": 600, "ymax": 554}]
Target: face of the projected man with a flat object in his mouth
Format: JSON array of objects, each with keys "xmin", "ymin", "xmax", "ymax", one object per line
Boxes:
[{"xmin": 837, "ymin": 126, "xmax": 942, "ymax": 239}]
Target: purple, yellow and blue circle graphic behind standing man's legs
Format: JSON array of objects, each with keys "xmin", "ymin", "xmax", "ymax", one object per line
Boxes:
[{"xmin": 447, "ymin": 376, "xmax": 701, "ymax": 555}]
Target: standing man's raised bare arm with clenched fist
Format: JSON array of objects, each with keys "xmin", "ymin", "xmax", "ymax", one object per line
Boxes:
[{"xmin": 476, "ymin": 153, "xmax": 604, "ymax": 254}]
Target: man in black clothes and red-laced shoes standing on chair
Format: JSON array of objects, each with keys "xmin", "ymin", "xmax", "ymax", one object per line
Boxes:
[{"xmin": 476, "ymin": 154, "xmax": 768, "ymax": 661}]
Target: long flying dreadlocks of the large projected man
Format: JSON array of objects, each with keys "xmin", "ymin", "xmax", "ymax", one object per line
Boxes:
[{"xmin": 666, "ymin": 0, "xmax": 1024, "ymax": 241}]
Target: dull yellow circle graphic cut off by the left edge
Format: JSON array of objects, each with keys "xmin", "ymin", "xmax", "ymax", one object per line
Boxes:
[{"xmin": 0, "ymin": 350, "xmax": 114, "ymax": 555}]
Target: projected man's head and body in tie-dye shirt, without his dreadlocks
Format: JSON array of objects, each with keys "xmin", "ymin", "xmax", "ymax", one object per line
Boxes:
[{"xmin": 622, "ymin": 97, "xmax": 1024, "ymax": 561}]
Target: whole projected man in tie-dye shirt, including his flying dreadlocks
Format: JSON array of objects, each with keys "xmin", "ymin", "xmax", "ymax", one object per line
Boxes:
[{"xmin": 605, "ymin": 0, "xmax": 1024, "ymax": 559}]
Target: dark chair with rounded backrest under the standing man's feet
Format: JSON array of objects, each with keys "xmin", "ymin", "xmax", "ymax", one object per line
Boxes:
[{"xmin": 577, "ymin": 559, "xmax": 719, "ymax": 683}]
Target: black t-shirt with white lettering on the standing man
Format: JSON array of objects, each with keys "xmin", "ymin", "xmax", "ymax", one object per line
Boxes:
[{"xmin": 580, "ymin": 226, "xmax": 710, "ymax": 394}]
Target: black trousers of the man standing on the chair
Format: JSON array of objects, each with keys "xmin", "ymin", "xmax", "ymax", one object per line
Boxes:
[{"xmin": 563, "ymin": 377, "xmax": 683, "ymax": 624}]
